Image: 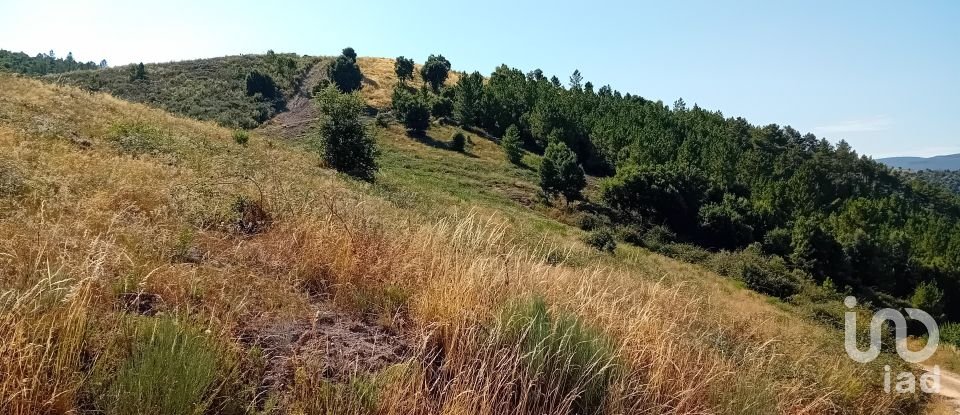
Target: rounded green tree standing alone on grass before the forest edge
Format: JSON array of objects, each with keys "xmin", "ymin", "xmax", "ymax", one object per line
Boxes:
[{"xmin": 540, "ymin": 141, "xmax": 587, "ymax": 203}]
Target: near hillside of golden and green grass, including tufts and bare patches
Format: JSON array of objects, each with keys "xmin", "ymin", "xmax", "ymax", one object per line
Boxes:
[{"xmin": 0, "ymin": 66, "xmax": 923, "ymax": 414}]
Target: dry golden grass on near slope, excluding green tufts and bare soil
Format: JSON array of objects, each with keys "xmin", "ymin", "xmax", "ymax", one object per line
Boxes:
[{"xmin": 0, "ymin": 73, "xmax": 921, "ymax": 414}]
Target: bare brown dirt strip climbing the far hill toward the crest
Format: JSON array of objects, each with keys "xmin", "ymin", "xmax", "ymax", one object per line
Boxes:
[{"xmin": 260, "ymin": 60, "xmax": 327, "ymax": 138}]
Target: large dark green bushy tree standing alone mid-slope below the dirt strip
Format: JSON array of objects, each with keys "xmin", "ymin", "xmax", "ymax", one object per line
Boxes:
[{"xmin": 316, "ymin": 87, "xmax": 378, "ymax": 181}]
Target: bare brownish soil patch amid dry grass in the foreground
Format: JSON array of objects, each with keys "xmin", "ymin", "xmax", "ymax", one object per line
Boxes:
[{"xmin": 240, "ymin": 305, "xmax": 411, "ymax": 390}]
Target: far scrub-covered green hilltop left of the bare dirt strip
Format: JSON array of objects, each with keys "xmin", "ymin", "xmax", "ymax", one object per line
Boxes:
[{"xmin": 47, "ymin": 53, "xmax": 321, "ymax": 128}]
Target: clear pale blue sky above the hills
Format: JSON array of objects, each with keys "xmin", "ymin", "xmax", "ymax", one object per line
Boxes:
[{"xmin": 0, "ymin": 0, "xmax": 960, "ymax": 157}]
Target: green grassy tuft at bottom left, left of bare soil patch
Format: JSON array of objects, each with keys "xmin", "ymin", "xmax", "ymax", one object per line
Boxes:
[{"xmin": 98, "ymin": 318, "xmax": 224, "ymax": 415}]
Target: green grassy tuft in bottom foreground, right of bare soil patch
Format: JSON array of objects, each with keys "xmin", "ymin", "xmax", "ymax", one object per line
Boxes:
[{"xmin": 497, "ymin": 297, "xmax": 616, "ymax": 414}]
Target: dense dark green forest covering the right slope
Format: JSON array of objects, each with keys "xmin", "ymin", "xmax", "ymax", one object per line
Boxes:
[{"xmin": 360, "ymin": 56, "xmax": 960, "ymax": 319}]
